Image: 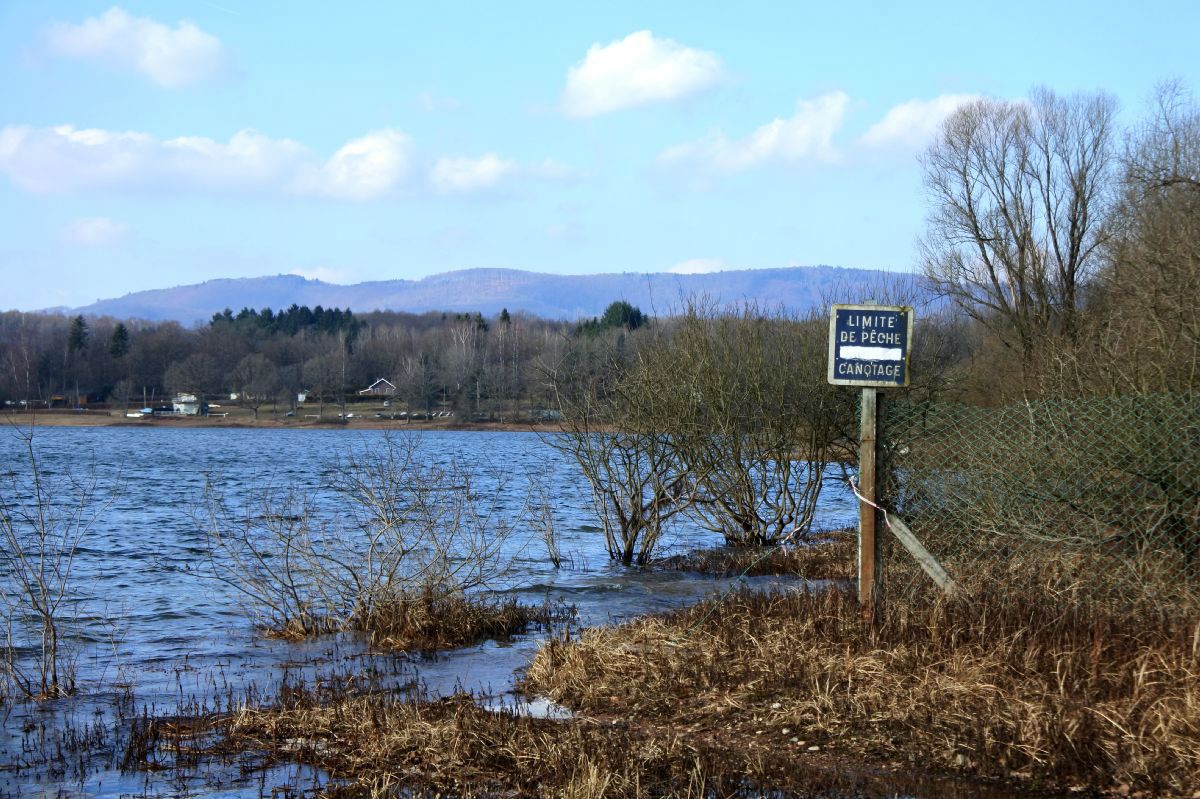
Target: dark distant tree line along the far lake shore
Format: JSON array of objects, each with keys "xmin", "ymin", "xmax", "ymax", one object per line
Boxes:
[{"xmin": 0, "ymin": 295, "xmax": 646, "ymax": 419}]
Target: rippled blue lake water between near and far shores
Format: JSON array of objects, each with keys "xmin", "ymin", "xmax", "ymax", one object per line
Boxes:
[{"xmin": 0, "ymin": 427, "xmax": 857, "ymax": 797}]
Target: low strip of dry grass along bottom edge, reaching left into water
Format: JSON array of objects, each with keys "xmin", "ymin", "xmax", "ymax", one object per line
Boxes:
[{"xmin": 125, "ymin": 686, "xmax": 1036, "ymax": 799}]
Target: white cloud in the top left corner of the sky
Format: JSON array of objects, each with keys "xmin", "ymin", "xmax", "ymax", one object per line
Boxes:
[{"xmin": 47, "ymin": 6, "xmax": 228, "ymax": 89}]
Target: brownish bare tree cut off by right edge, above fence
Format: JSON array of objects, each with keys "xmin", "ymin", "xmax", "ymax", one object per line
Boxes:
[{"xmin": 1042, "ymin": 83, "xmax": 1200, "ymax": 396}]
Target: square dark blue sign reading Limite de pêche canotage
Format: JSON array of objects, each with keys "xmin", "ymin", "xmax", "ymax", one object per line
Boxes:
[{"xmin": 829, "ymin": 305, "xmax": 912, "ymax": 389}]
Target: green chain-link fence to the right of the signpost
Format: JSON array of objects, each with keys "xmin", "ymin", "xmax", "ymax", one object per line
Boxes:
[{"xmin": 878, "ymin": 394, "xmax": 1200, "ymax": 609}]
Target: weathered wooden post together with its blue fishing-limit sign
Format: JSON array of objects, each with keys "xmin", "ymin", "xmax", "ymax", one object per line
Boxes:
[{"xmin": 828, "ymin": 302, "xmax": 913, "ymax": 615}]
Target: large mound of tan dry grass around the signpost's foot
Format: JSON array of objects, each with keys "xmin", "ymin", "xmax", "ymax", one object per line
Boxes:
[{"xmin": 527, "ymin": 583, "xmax": 1200, "ymax": 795}]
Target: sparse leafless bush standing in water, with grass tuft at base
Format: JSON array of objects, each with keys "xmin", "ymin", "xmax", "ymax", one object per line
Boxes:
[{"xmin": 206, "ymin": 429, "xmax": 530, "ymax": 645}]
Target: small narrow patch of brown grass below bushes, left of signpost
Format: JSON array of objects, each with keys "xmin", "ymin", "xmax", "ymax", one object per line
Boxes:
[{"xmin": 653, "ymin": 530, "xmax": 857, "ymax": 579}]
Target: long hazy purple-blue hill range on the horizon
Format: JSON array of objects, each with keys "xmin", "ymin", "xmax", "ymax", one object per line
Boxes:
[{"xmin": 70, "ymin": 266, "xmax": 902, "ymax": 324}]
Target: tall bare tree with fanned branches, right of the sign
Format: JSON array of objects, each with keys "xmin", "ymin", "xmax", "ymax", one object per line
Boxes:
[{"xmin": 922, "ymin": 89, "xmax": 1116, "ymax": 367}]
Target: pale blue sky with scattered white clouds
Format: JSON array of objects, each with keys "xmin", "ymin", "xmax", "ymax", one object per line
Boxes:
[{"xmin": 0, "ymin": 0, "xmax": 1200, "ymax": 310}]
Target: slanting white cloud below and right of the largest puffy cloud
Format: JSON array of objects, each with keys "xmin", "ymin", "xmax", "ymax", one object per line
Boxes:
[{"xmin": 659, "ymin": 91, "xmax": 850, "ymax": 173}]
